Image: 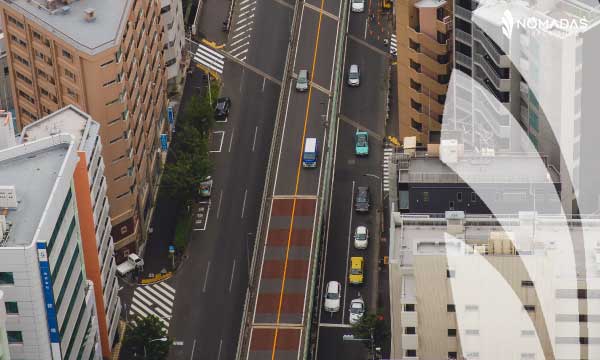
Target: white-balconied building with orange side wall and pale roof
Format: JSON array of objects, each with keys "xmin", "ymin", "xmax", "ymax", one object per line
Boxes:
[{"xmin": 21, "ymin": 105, "xmax": 121, "ymax": 357}]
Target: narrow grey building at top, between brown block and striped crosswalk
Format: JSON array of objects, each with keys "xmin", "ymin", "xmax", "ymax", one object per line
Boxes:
[{"xmin": 160, "ymin": 0, "xmax": 185, "ymax": 91}]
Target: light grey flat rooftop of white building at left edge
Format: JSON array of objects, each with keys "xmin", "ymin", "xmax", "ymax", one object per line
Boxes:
[{"xmin": 0, "ymin": 134, "xmax": 73, "ymax": 247}]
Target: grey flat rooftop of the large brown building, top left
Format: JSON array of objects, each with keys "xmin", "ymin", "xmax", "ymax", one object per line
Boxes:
[{"xmin": 5, "ymin": 0, "xmax": 132, "ymax": 55}]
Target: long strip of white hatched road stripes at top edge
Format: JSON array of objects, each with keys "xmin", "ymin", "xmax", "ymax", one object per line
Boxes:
[{"xmin": 227, "ymin": 0, "xmax": 256, "ymax": 61}]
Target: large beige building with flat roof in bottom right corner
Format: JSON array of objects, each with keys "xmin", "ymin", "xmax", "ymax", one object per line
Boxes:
[{"xmin": 390, "ymin": 212, "xmax": 600, "ymax": 360}]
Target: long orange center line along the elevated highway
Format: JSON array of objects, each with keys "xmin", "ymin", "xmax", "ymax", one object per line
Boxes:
[{"xmin": 271, "ymin": 0, "xmax": 325, "ymax": 360}]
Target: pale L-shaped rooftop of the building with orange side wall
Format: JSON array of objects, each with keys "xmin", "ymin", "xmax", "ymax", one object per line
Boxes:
[{"xmin": 21, "ymin": 105, "xmax": 100, "ymax": 161}]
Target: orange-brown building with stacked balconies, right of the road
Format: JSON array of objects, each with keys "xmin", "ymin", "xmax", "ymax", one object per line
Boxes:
[{"xmin": 395, "ymin": 0, "xmax": 452, "ymax": 146}]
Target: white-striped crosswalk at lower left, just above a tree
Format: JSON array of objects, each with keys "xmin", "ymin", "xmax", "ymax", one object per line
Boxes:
[{"xmin": 129, "ymin": 282, "xmax": 175, "ymax": 331}]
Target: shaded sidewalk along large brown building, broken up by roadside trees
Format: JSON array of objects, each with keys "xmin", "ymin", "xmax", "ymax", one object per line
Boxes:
[{"xmin": 144, "ymin": 66, "xmax": 206, "ymax": 276}]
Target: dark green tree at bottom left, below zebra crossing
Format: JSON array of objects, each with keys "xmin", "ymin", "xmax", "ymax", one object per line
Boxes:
[{"xmin": 123, "ymin": 315, "xmax": 173, "ymax": 360}]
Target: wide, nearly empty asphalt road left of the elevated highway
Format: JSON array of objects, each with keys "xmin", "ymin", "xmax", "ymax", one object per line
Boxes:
[{"xmin": 169, "ymin": 1, "xmax": 292, "ymax": 360}]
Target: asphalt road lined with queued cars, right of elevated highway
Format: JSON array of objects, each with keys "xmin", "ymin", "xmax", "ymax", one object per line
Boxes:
[{"xmin": 316, "ymin": 1, "xmax": 389, "ymax": 360}]
